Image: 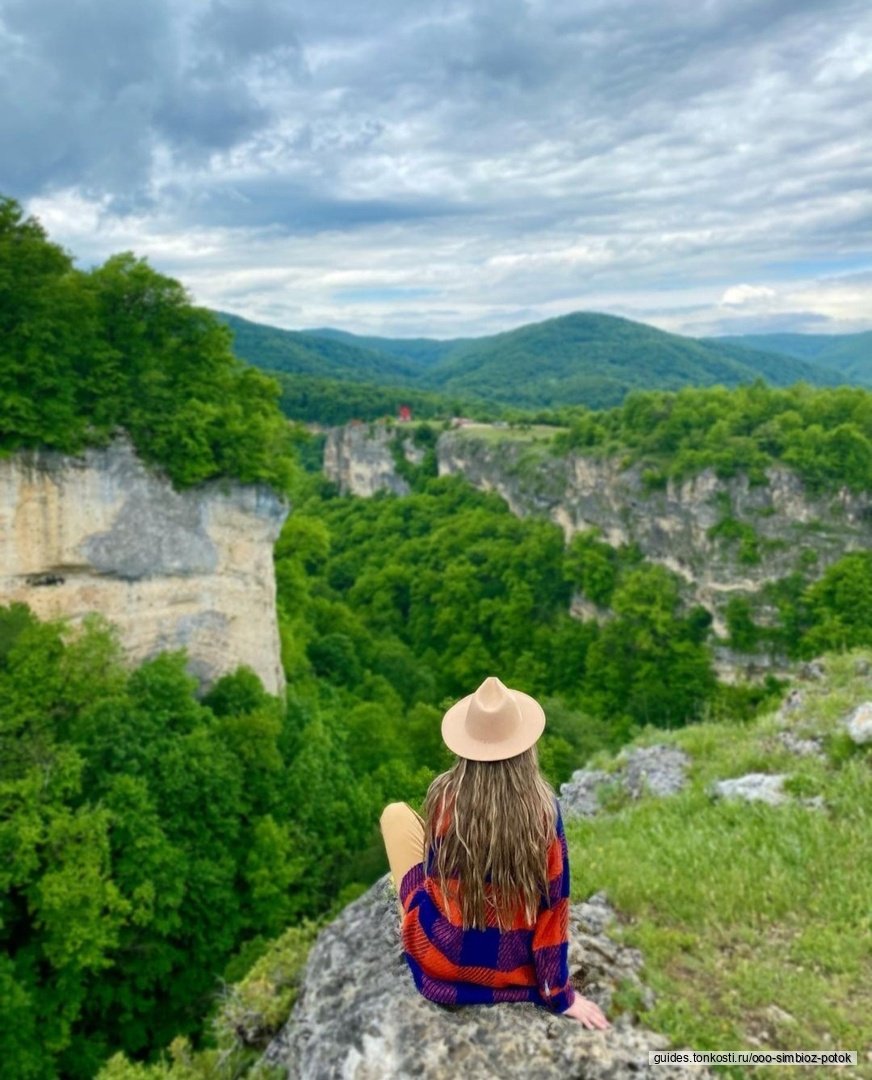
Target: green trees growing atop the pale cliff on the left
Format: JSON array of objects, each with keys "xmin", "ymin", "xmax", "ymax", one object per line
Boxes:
[{"xmin": 0, "ymin": 197, "xmax": 293, "ymax": 491}]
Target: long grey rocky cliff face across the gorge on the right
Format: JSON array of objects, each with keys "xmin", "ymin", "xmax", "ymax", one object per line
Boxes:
[{"xmin": 324, "ymin": 427, "xmax": 872, "ymax": 669}]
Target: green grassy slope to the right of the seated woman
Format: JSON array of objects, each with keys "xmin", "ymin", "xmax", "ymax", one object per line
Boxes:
[{"xmin": 567, "ymin": 649, "xmax": 872, "ymax": 1080}]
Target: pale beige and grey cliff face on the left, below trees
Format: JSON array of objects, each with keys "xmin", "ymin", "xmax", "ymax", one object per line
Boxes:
[{"xmin": 0, "ymin": 435, "xmax": 290, "ymax": 693}]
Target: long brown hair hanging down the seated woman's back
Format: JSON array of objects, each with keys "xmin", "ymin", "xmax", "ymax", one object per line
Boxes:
[{"xmin": 424, "ymin": 744, "xmax": 556, "ymax": 930}]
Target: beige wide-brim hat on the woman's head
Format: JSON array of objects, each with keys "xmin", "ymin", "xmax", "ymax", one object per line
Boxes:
[{"xmin": 442, "ymin": 675, "xmax": 545, "ymax": 761}]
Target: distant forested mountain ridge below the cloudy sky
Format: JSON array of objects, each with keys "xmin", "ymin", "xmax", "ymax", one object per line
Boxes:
[{"xmin": 219, "ymin": 312, "xmax": 843, "ymax": 408}]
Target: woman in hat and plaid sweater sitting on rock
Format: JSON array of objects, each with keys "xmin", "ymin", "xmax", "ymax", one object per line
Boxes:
[{"xmin": 380, "ymin": 677, "xmax": 609, "ymax": 1028}]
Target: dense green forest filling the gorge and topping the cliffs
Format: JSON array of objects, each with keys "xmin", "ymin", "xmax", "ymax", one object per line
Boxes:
[{"xmin": 0, "ymin": 200, "xmax": 872, "ymax": 1080}]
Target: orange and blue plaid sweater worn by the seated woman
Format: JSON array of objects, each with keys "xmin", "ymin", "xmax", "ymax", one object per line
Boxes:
[{"xmin": 400, "ymin": 799, "xmax": 575, "ymax": 1012}]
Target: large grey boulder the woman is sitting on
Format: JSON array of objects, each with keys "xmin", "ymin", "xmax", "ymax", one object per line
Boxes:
[{"xmin": 264, "ymin": 875, "xmax": 710, "ymax": 1080}]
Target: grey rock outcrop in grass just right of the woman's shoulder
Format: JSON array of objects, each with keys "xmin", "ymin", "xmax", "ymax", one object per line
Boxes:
[{"xmin": 560, "ymin": 743, "xmax": 690, "ymax": 818}]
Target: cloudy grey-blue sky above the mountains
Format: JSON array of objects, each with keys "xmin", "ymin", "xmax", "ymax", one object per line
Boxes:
[{"xmin": 0, "ymin": 0, "xmax": 872, "ymax": 337}]
